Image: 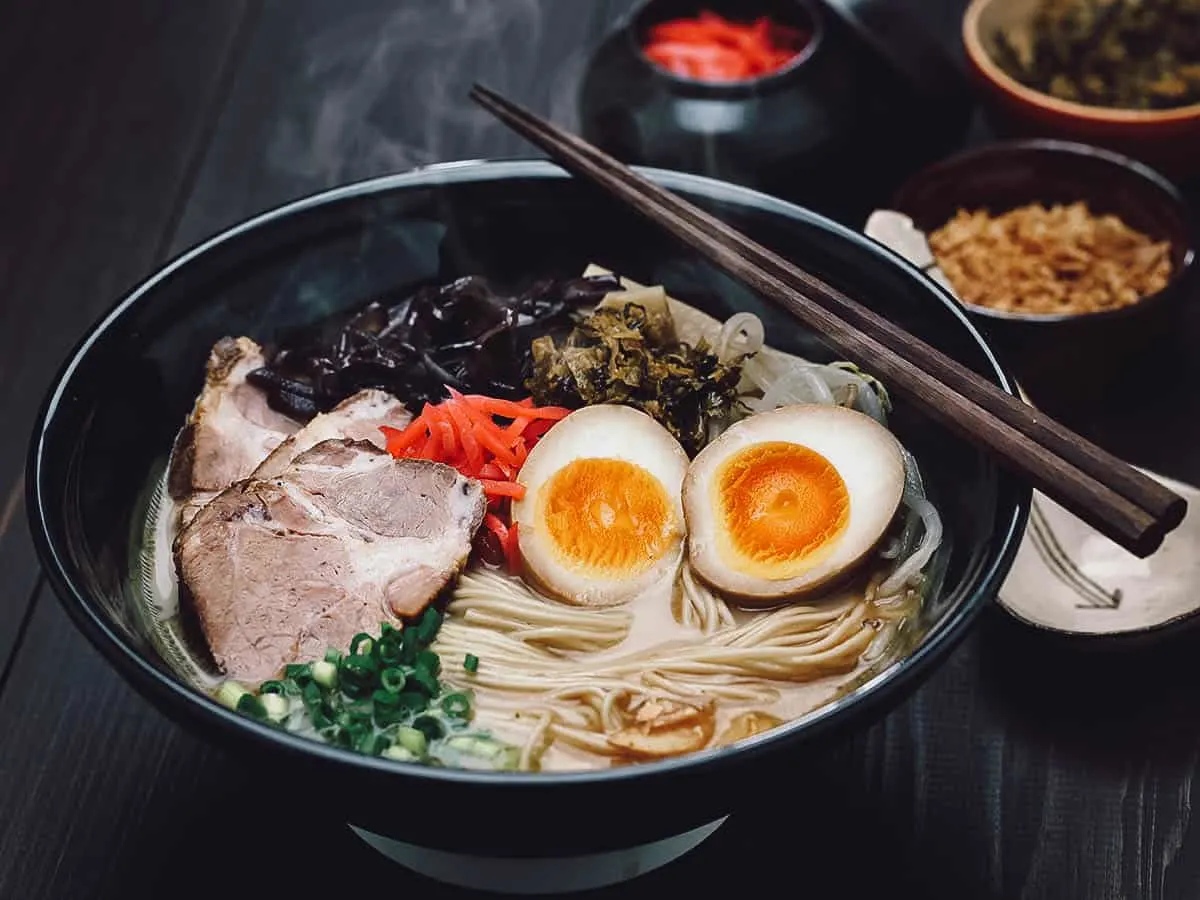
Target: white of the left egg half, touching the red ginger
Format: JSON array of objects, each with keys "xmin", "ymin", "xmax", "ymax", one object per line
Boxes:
[{"xmin": 512, "ymin": 404, "xmax": 688, "ymax": 606}]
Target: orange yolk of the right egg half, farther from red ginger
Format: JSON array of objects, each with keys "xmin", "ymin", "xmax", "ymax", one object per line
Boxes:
[{"xmin": 715, "ymin": 440, "xmax": 850, "ymax": 578}]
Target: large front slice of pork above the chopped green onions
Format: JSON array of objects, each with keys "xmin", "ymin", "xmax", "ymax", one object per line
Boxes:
[{"xmin": 175, "ymin": 440, "xmax": 486, "ymax": 682}]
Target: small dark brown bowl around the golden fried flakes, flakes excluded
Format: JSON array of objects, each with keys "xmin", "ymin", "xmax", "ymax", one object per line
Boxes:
[{"xmin": 892, "ymin": 140, "xmax": 1200, "ymax": 408}]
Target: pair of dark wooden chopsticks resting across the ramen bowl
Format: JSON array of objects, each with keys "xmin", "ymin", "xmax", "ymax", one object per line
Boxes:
[{"xmin": 470, "ymin": 84, "xmax": 1187, "ymax": 557}]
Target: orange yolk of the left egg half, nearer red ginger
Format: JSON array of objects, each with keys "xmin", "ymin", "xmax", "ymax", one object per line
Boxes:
[{"xmin": 539, "ymin": 458, "xmax": 674, "ymax": 576}]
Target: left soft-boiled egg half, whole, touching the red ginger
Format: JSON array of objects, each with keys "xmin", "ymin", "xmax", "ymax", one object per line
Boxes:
[{"xmin": 512, "ymin": 404, "xmax": 688, "ymax": 606}]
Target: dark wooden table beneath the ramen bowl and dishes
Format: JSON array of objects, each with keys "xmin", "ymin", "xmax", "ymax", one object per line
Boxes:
[{"xmin": 0, "ymin": 0, "xmax": 1200, "ymax": 900}]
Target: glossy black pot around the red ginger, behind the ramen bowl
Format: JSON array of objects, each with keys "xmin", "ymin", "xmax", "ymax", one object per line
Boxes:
[{"xmin": 580, "ymin": 0, "xmax": 970, "ymax": 224}]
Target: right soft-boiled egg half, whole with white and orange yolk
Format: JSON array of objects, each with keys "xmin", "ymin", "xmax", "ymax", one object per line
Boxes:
[{"xmin": 683, "ymin": 406, "xmax": 905, "ymax": 606}]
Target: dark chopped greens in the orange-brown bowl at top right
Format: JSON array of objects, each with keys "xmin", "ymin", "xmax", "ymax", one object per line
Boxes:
[{"xmin": 996, "ymin": 0, "xmax": 1200, "ymax": 109}]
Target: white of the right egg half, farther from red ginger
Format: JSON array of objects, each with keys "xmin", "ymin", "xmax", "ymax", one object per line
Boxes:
[{"xmin": 683, "ymin": 404, "xmax": 905, "ymax": 606}]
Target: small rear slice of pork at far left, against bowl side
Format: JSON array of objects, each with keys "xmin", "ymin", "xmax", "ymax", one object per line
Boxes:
[{"xmin": 167, "ymin": 337, "xmax": 300, "ymax": 524}]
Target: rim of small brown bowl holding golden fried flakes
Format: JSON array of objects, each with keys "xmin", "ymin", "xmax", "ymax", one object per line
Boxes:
[{"xmin": 889, "ymin": 138, "xmax": 1200, "ymax": 325}]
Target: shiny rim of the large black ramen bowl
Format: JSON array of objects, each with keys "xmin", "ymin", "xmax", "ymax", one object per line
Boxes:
[{"xmin": 25, "ymin": 158, "xmax": 1032, "ymax": 791}]
